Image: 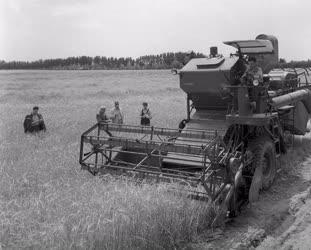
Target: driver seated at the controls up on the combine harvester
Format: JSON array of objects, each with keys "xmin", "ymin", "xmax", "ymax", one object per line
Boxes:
[{"xmin": 241, "ymin": 57, "xmax": 263, "ymax": 86}]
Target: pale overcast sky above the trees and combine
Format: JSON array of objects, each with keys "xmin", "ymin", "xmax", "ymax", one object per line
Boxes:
[{"xmin": 0, "ymin": 0, "xmax": 311, "ymax": 61}]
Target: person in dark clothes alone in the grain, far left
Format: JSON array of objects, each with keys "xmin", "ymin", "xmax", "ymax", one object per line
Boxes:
[{"xmin": 24, "ymin": 106, "xmax": 46, "ymax": 133}]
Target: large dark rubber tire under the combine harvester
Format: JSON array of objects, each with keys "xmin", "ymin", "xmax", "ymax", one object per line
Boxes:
[{"xmin": 248, "ymin": 136, "xmax": 276, "ymax": 190}]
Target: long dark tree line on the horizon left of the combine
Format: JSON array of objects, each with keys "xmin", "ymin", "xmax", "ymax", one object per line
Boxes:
[{"xmin": 0, "ymin": 51, "xmax": 205, "ymax": 70}]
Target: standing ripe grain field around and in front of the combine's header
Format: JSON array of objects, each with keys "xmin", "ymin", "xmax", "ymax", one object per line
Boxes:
[{"xmin": 0, "ymin": 71, "xmax": 217, "ymax": 249}]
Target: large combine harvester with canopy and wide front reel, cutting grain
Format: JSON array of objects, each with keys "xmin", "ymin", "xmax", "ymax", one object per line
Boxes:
[{"xmin": 80, "ymin": 35, "xmax": 311, "ymax": 221}]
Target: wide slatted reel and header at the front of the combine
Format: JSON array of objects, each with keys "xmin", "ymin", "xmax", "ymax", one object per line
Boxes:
[{"xmin": 80, "ymin": 123, "xmax": 249, "ymax": 223}]
